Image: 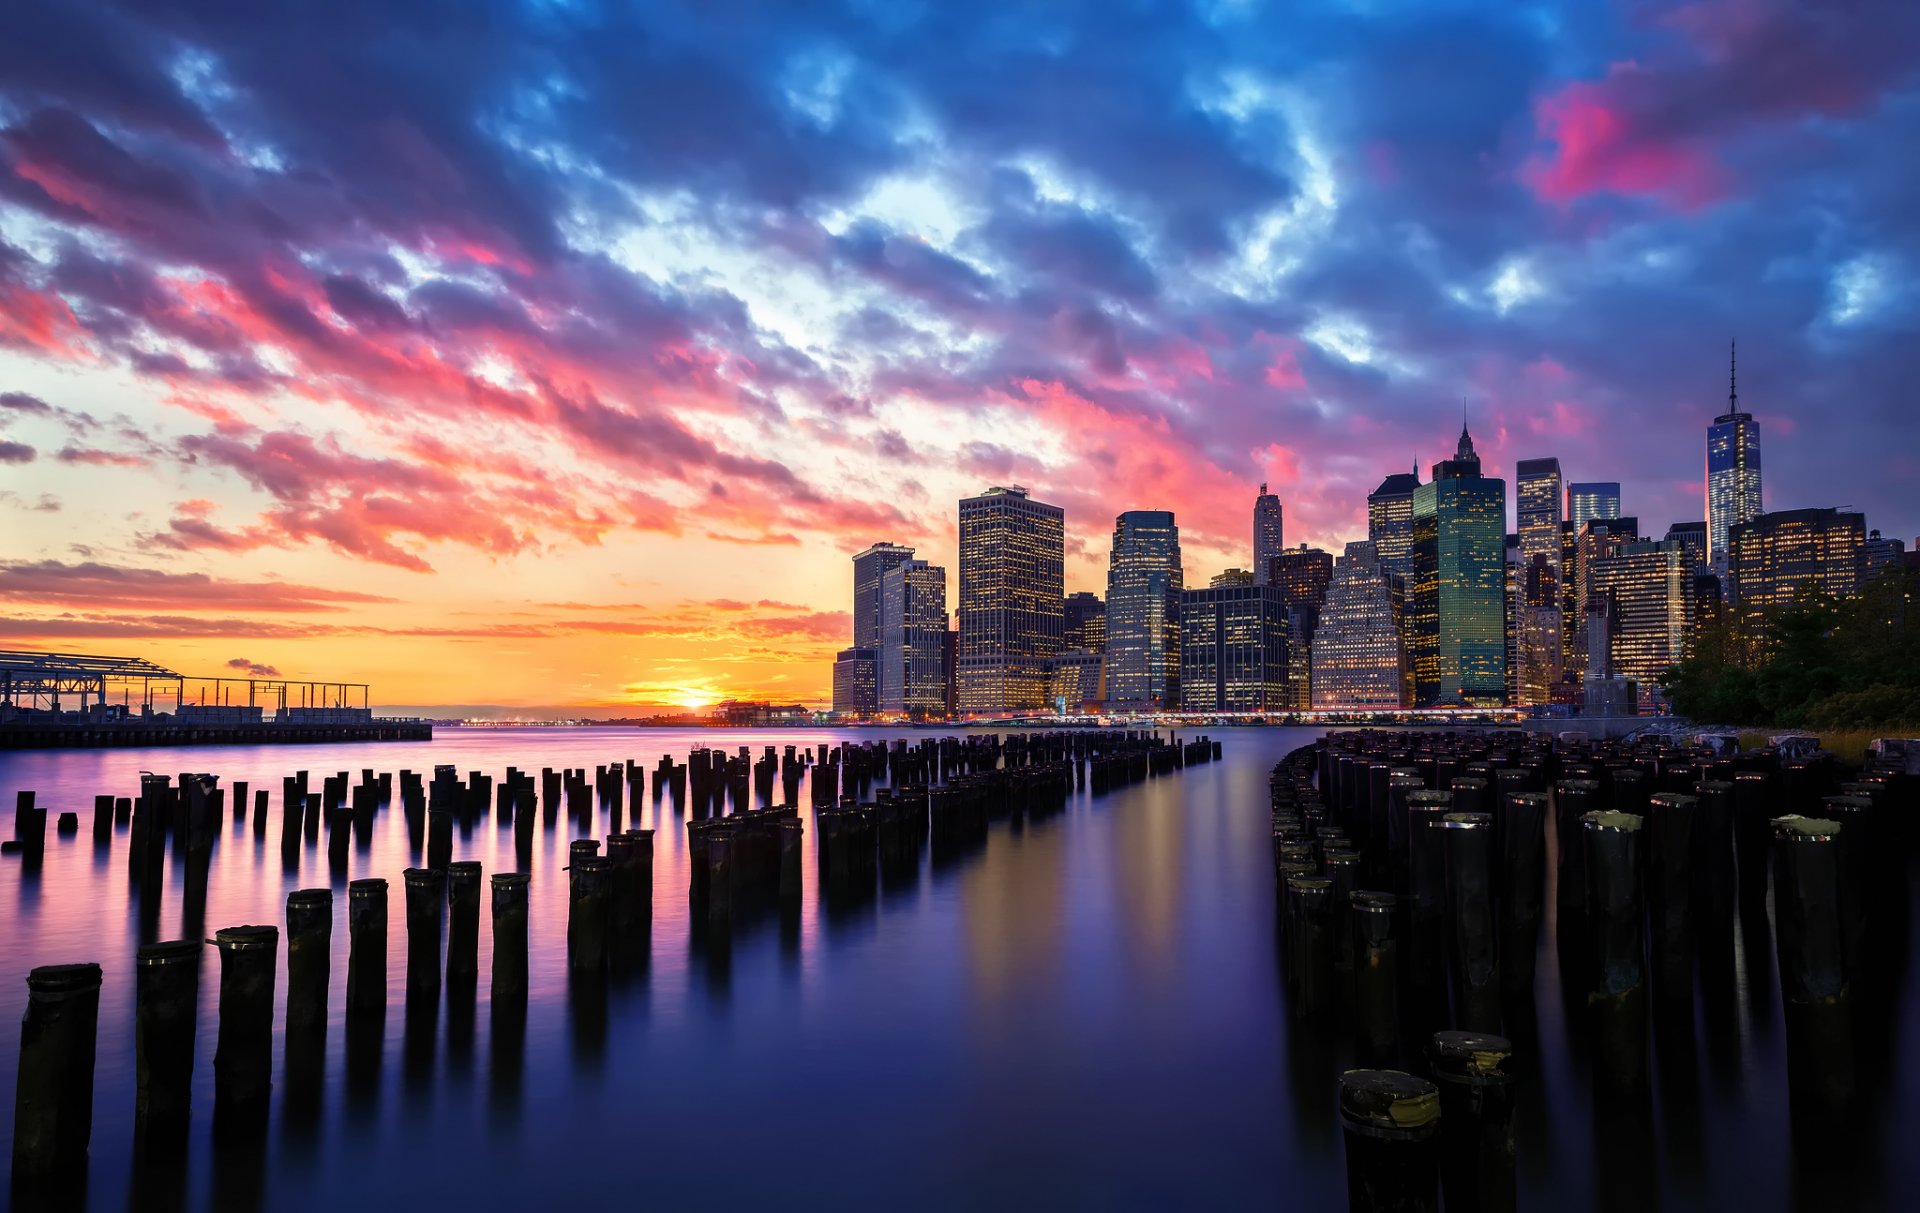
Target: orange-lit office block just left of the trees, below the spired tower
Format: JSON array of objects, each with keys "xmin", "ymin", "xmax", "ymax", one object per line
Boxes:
[{"xmin": 1588, "ymin": 539, "xmax": 1695, "ymax": 701}]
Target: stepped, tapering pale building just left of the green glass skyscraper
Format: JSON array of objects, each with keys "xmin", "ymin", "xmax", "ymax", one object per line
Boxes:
[{"xmin": 1311, "ymin": 541, "xmax": 1405, "ymax": 710}]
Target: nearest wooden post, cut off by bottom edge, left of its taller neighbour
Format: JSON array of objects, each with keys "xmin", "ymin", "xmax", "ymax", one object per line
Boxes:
[{"xmin": 1340, "ymin": 1069, "xmax": 1440, "ymax": 1213}]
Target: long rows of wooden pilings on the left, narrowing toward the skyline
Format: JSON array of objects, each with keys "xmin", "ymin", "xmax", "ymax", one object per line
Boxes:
[{"xmin": 8, "ymin": 731, "xmax": 1219, "ymax": 1192}]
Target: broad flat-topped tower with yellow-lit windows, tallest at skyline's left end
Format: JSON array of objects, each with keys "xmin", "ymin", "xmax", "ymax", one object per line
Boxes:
[{"xmin": 954, "ymin": 486, "xmax": 1066, "ymax": 716}]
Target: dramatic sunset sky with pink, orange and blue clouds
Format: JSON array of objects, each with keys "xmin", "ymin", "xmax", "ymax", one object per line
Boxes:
[{"xmin": 0, "ymin": 0, "xmax": 1920, "ymax": 708}]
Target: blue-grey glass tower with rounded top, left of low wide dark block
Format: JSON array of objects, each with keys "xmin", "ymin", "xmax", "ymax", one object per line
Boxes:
[{"xmin": 1106, "ymin": 511, "xmax": 1185, "ymax": 708}]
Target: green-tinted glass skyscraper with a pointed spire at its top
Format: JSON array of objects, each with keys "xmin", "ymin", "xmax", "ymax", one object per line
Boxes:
[{"xmin": 1409, "ymin": 426, "xmax": 1507, "ymax": 706}]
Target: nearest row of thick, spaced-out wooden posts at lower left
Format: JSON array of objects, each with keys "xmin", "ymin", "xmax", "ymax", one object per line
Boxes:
[{"xmin": 13, "ymin": 856, "xmax": 560, "ymax": 1198}]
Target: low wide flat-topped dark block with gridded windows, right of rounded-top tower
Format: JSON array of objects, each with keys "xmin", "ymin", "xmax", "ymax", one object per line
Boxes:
[{"xmin": 1179, "ymin": 574, "xmax": 1296, "ymax": 712}]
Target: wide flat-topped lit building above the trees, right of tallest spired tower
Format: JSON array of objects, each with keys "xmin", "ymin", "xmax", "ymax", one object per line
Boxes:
[{"xmin": 1726, "ymin": 509, "xmax": 1866, "ymax": 624}]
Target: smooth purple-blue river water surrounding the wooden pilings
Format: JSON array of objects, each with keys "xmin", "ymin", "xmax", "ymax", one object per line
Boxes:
[{"xmin": 0, "ymin": 729, "xmax": 1920, "ymax": 1211}]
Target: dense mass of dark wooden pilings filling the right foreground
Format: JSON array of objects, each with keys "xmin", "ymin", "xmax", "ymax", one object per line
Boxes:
[{"xmin": 1271, "ymin": 731, "xmax": 1920, "ymax": 1209}]
